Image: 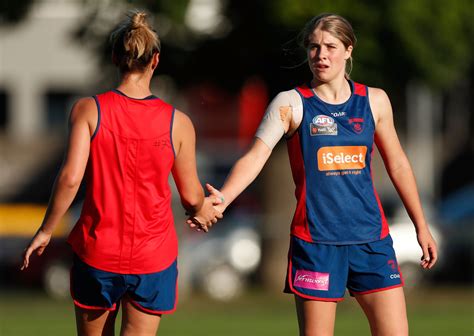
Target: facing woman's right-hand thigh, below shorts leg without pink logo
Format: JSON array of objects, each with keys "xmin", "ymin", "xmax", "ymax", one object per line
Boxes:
[{"xmin": 355, "ymin": 287, "xmax": 408, "ymax": 336}]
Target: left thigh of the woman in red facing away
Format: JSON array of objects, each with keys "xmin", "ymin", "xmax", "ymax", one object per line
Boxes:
[{"xmin": 75, "ymin": 305, "xmax": 118, "ymax": 336}]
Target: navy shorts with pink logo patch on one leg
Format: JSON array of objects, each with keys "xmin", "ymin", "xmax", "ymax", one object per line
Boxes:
[{"xmin": 284, "ymin": 235, "xmax": 403, "ymax": 301}]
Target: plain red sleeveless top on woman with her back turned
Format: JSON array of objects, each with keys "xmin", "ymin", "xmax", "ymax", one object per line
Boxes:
[{"xmin": 68, "ymin": 90, "xmax": 178, "ymax": 274}]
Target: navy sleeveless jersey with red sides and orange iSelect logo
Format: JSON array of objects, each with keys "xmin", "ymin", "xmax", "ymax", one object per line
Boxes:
[{"xmin": 287, "ymin": 81, "xmax": 388, "ymax": 244}]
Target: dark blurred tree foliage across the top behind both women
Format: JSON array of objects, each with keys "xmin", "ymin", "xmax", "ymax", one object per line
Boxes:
[{"xmin": 0, "ymin": 0, "xmax": 474, "ymax": 95}]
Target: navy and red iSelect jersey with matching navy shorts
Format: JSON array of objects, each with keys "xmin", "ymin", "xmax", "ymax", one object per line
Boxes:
[{"xmin": 257, "ymin": 81, "xmax": 403, "ymax": 301}]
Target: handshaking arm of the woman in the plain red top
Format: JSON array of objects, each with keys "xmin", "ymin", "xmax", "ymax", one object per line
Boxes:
[{"xmin": 172, "ymin": 110, "xmax": 222, "ymax": 229}]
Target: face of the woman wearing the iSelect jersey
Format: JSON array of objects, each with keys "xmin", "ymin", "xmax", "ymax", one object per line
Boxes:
[{"xmin": 307, "ymin": 28, "xmax": 352, "ymax": 83}]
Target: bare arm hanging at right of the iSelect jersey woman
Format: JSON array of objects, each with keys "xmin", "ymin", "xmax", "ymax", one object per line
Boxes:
[{"xmin": 369, "ymin": 88, "xmax": 438, "ymax": 268}]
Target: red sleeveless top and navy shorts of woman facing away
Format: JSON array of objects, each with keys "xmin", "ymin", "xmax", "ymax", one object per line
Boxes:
[{"xmin": 68, "ymin": 90, "xmax": 178, "ymax": 314}]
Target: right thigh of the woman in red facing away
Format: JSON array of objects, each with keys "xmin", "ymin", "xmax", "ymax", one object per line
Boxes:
[{"xmin": 120, "ymin": 295, "xmax": 161, "ymax": 336}]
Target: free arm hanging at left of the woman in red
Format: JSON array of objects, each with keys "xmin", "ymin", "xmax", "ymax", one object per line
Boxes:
[{"xmin": 21, "ymin": 98, "xmax": 97, "ymax": 270}]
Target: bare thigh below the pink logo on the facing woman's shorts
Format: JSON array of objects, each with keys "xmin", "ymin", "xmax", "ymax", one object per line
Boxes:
[{"xmin": 295, "ymin": 295, "xmax": 337, "ymax": 336}]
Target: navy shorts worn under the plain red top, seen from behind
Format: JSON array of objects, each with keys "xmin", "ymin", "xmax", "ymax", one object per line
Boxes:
[{"xmin": 71, "ymin": 255, "xmax": 178, "ymax": 315}]
